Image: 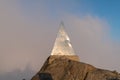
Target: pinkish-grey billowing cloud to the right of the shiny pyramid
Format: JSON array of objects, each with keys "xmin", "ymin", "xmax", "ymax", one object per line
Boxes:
[{"xmin": 63, "ymin": 15, "xmax": 120, "ymax": 71}]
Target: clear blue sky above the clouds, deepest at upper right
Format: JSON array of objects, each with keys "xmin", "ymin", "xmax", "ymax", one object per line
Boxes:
[{"xmin": 20, "ymin": 0, "xmax": 120, "ymax": 41}]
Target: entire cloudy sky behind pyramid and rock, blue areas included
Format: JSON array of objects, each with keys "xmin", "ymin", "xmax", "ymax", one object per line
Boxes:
[{"xmin": 0, "ymin": 0, "xmax": 120, "ymax": 80}]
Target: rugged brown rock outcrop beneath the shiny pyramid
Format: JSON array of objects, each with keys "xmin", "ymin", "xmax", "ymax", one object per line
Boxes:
[{"xmin": 31, "ymin": 56, "xmax": 120, "ymax": 80}]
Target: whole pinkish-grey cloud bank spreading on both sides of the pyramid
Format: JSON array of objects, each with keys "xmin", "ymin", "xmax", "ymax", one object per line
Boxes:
[{"xmin": 0, "ymin": 0, "xmax": 120, "ymax": 80}]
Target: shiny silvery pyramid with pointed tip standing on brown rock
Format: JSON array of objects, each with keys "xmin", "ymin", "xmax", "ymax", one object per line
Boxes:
[{"xmin": 51, "ymin": 22, "xmax": 75, "ymax": 55}]
